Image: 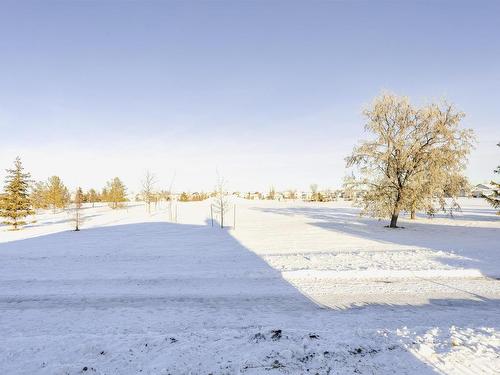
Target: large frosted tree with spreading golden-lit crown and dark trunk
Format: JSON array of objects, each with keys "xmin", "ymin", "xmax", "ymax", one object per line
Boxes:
[{"xmin": 346, "ymin": 94, "xmax": 474, "ymax": 228}]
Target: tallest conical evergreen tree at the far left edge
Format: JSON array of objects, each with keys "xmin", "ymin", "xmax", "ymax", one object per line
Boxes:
[{"xmin": 0, "ymin": 157, "xmax": 34, "ymax": 230}]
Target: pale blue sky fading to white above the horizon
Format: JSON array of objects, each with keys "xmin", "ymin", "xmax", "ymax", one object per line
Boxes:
[{"xmin": 0, "ymin": 1, "xmax": 500, "ymax": 191}]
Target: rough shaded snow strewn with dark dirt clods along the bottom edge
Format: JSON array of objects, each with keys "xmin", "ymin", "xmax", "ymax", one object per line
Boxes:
[{"xmin": 0, "ymin": 328, "xmax": 427, "ymax": 375}]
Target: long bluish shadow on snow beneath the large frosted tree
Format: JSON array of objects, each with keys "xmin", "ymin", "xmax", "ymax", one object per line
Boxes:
[{"xmin": 257, "ymin": 207, "xmax": 500, "ymax": 278}]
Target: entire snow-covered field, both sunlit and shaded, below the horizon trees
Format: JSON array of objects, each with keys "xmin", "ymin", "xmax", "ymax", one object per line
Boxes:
[{"xmin": 0, "ymin": 199, "xmax": 500, "ymax": 375}]
